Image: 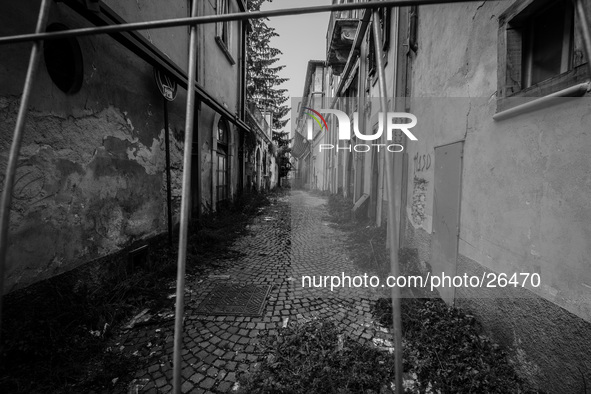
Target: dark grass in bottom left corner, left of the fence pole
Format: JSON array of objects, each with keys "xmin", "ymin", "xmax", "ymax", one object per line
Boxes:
[{"xmin": 0, "ymin": 235, "xmax": 174, "ymax": 393}]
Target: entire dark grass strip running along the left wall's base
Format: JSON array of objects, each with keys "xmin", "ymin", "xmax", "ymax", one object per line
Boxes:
[{"xmin": 0, "ymin": 190, "xmax": 276, "ymax": 393}]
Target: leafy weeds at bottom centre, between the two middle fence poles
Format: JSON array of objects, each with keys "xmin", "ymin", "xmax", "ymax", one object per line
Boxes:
[{"xmin": 241, "ymin": 320, "xmax": 394, "ymax": 394}]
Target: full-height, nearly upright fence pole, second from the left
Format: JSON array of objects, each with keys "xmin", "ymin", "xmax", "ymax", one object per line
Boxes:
[{"xmin": 172, "ymin": 0, "xmax": 198, "ymax": 394}]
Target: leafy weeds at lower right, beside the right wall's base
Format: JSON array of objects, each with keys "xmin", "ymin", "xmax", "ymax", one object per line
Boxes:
[{"xmin": 372, "ymin": 298, "xmax": 533, "ymax": 394}]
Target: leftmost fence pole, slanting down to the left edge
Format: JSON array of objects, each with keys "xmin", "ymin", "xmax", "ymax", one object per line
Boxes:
[{"xmin": 0, "ymin": 0, "xmax": 51, "ymax": 338}]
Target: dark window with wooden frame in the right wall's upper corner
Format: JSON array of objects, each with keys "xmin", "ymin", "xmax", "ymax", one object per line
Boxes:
[{"xmin": 497, "ymin": 0, "xmax": 588, "ymax": 110}]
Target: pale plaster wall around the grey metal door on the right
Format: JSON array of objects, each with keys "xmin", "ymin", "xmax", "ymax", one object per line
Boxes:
[{"xmin": 406, "ymin": 2, "xmax": 591, "ymax": 393}]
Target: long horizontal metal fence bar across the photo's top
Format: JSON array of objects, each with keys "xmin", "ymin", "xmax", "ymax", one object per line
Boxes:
[{"xmin": 0, "ymin": 0, "xmax": 494, "ymax": 45}]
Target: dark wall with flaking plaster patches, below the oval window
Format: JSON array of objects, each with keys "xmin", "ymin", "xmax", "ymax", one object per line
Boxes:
[{"xmin": 0, "ymin": 2, "xmax": 185, "ymax": 291}]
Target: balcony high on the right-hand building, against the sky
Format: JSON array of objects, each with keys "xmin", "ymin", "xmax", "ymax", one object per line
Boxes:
[{"xmin": 326, "ymin": 4, "xmax": 363, "ymax": 75}]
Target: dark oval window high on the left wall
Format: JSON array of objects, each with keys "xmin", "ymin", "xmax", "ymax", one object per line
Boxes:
[{"xmin": 43, "ymin": 23, "xmax": 84, "ymax": 94}]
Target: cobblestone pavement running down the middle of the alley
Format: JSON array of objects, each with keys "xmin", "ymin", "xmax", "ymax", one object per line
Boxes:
[{"xmin": 106, "ymin": 191, "xmax": 394, "ymax": 393}]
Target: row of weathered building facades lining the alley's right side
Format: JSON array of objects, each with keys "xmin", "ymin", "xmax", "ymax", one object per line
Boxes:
[{"xmin": 298, "ymin": 0, "xmax": 591, "ymax": 393}]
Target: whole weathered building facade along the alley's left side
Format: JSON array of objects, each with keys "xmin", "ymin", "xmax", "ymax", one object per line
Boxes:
[{"xmin": 0, "ymin": 0, "xmax": 268, "ymax": 291}]
